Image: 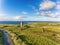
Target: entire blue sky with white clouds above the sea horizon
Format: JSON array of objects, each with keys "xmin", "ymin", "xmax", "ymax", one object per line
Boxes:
[{"xmin": 0, "ymin": 0, "xmax": 60, "ymax": 21}]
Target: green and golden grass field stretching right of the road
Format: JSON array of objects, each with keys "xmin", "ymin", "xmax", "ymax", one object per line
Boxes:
[{"xmin": 0, "ymin": 22, "xmax": 60, "ymax": 45}]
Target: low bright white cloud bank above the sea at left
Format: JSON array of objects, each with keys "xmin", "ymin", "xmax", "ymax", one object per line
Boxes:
[{"xmin": 0, "ymin": 12, "xmax": 25, "ymax": 21}]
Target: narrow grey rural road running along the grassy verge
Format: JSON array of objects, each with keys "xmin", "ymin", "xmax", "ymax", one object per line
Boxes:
[{"xmin": 2, "ymin": 30, "xmax": 14, "ymax": 45}]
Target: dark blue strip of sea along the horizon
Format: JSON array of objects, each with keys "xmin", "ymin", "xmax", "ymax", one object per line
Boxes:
[{"xmin": 0, "ymin": 21, "xmax": 57, "ymax": 24}]
